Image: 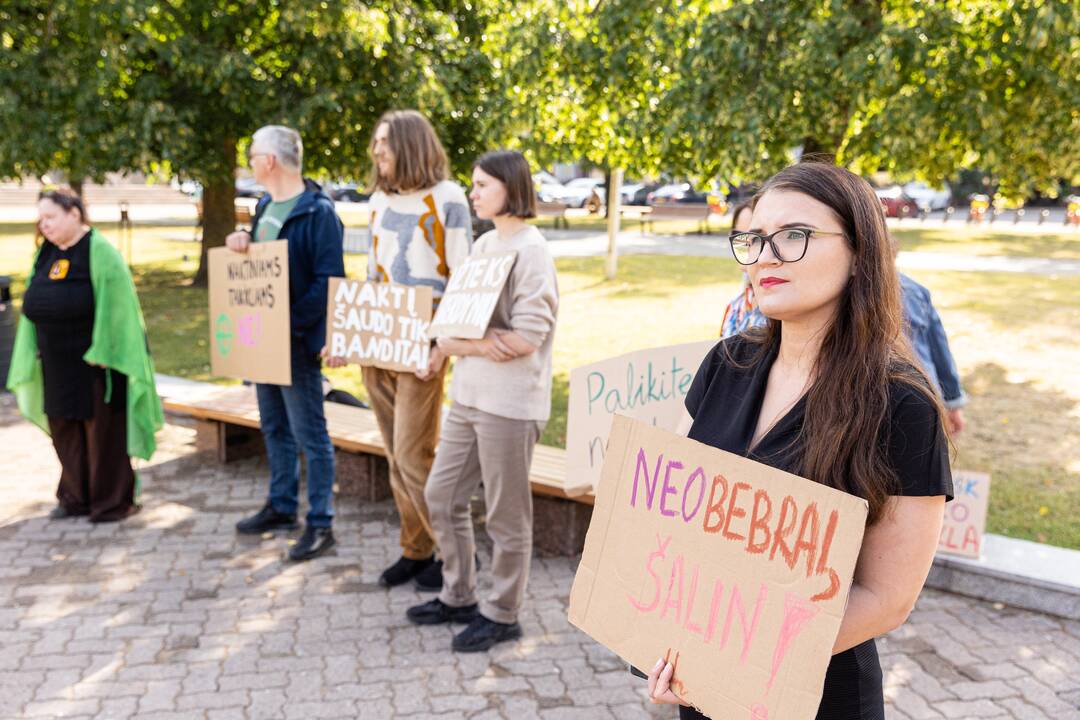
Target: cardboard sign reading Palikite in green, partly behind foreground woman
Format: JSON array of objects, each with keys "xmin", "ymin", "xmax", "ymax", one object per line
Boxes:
[{"xmin": 566, "ymin": 340, "xmax": 716, "ymax": 492}]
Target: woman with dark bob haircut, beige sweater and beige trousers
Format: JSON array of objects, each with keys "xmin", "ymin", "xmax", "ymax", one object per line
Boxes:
[{"xmin": 406, "ymin": 150, "xmax": 558, "ymax": 652}]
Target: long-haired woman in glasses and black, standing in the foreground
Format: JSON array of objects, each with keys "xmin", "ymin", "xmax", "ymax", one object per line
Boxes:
[{"xmin": 649, "ymin": 162, "xmax": 953, "ymax": 720}]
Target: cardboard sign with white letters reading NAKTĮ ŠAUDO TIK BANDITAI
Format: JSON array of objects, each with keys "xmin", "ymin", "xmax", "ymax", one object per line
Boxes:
[{"xmin": 326, "ymin": 277, "xmax": 432, "ymax": 372}]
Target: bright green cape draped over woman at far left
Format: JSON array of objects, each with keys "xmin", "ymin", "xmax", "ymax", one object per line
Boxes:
[{"xmin": 8, "ymin": 229, "xmax": 164, "ymax": 460}]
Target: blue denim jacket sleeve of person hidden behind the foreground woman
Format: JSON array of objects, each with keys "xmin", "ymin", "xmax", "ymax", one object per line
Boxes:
[{"xmin": 900, "ymin": 273, "xmax": 968, "ymax": 409}]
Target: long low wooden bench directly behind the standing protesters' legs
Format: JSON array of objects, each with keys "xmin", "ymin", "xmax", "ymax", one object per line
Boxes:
[{"xmin": 159, "ymin": 382, "xmax": 594, "ymax": 555}]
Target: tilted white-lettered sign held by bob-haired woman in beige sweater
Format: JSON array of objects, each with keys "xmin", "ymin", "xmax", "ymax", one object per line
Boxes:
[{"xmin": 428, "ymin": 250, "xmax": 517, "ymax": 340}]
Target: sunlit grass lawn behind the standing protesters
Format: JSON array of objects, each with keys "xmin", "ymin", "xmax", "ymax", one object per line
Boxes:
[{"xmin": 0, "ymin": 222, "xmax": 1080, "ymax": 548}]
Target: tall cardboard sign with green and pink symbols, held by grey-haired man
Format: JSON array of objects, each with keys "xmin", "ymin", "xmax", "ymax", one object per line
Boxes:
[{"xmin": 206, "ymin": 240, "xmax": 293, "ymax": 385}]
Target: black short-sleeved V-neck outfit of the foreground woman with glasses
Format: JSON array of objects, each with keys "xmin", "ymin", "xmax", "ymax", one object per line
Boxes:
[{"xmin": 679, "ymin": 336, "xmax": 953, "ymax": 720}]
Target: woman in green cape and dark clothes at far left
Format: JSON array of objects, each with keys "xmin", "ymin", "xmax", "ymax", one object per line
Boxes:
[{"xmin": 8, "ymin": 189, "xmax": 163, "ymax": 522}]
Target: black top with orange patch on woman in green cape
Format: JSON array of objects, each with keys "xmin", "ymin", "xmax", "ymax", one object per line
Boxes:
[{"xmin": 23, "ymin": 233, "xmax": 126, "ymax": 420}]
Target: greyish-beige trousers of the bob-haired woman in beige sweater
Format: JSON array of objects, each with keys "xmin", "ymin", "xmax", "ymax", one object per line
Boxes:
[{"xmin": 424, "ymin": 403, "xmax": 543, "ymax": 623}]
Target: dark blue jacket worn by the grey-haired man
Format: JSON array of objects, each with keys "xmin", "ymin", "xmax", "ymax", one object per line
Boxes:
[{"xmin": 252, "ymin": 178, "xmax": 345, "ymax": 353}]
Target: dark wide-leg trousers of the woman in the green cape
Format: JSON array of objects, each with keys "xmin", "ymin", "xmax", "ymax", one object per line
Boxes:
[{"xmin": 49, "ymin": 380, "xmax": 135, "ymax": 522}]
